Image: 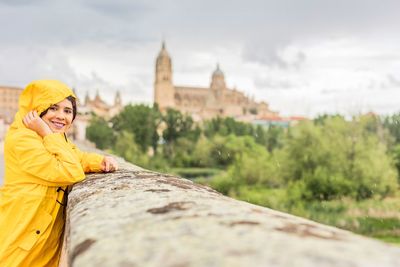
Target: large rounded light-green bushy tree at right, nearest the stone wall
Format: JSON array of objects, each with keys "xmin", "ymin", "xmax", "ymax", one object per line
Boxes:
[{"xmin": 284, "ymin": 118, "xmax": 397, "ymax": 200}]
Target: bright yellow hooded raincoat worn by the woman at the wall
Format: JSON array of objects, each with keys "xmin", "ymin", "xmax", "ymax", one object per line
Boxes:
[{"xmin": 0, "ymin": 80, "xmax": 103, "ymax": 267}]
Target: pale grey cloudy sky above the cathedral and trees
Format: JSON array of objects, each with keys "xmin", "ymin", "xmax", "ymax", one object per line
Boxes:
[{"xmin": 0, "ymin": 0, "xmax": 400, "ymax": 117}]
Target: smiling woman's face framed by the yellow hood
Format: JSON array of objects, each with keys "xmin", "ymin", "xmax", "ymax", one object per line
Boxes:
[{"xmin": 42, "ymin": 99, "xmax": 73, "ymax": 133}]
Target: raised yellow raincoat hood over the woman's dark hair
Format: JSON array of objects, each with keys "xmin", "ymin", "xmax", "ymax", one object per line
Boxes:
[{"xmin": 10, "ymin": 80, "xmax": 76, "ymax": 129}]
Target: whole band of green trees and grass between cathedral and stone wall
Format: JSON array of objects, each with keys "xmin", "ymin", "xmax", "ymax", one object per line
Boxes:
[{"xmin": 87, "ymin": 105, "xmax": 400, "ymax": 243}]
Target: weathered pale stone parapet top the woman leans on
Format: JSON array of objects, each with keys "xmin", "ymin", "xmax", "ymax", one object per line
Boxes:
[{"xmin": 62, "ymin": 158, "xmax": 400, "ymax": 267}]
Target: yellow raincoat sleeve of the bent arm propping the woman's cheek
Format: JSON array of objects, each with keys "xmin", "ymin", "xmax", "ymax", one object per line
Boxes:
[{"xmin": 14, "ymin": 130, "xmax": 85, "ymax": 185}]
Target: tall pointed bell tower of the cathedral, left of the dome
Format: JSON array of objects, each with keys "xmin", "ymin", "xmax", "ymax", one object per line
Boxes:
[{"xmin": 154, "ymin": 42, "xmax": 175, "ymax": 111}]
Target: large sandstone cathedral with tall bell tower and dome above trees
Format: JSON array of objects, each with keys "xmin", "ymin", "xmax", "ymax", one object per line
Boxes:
[{"xmin": 154, "ymin": 43, "xmax": 278, "ymax": 122}]
